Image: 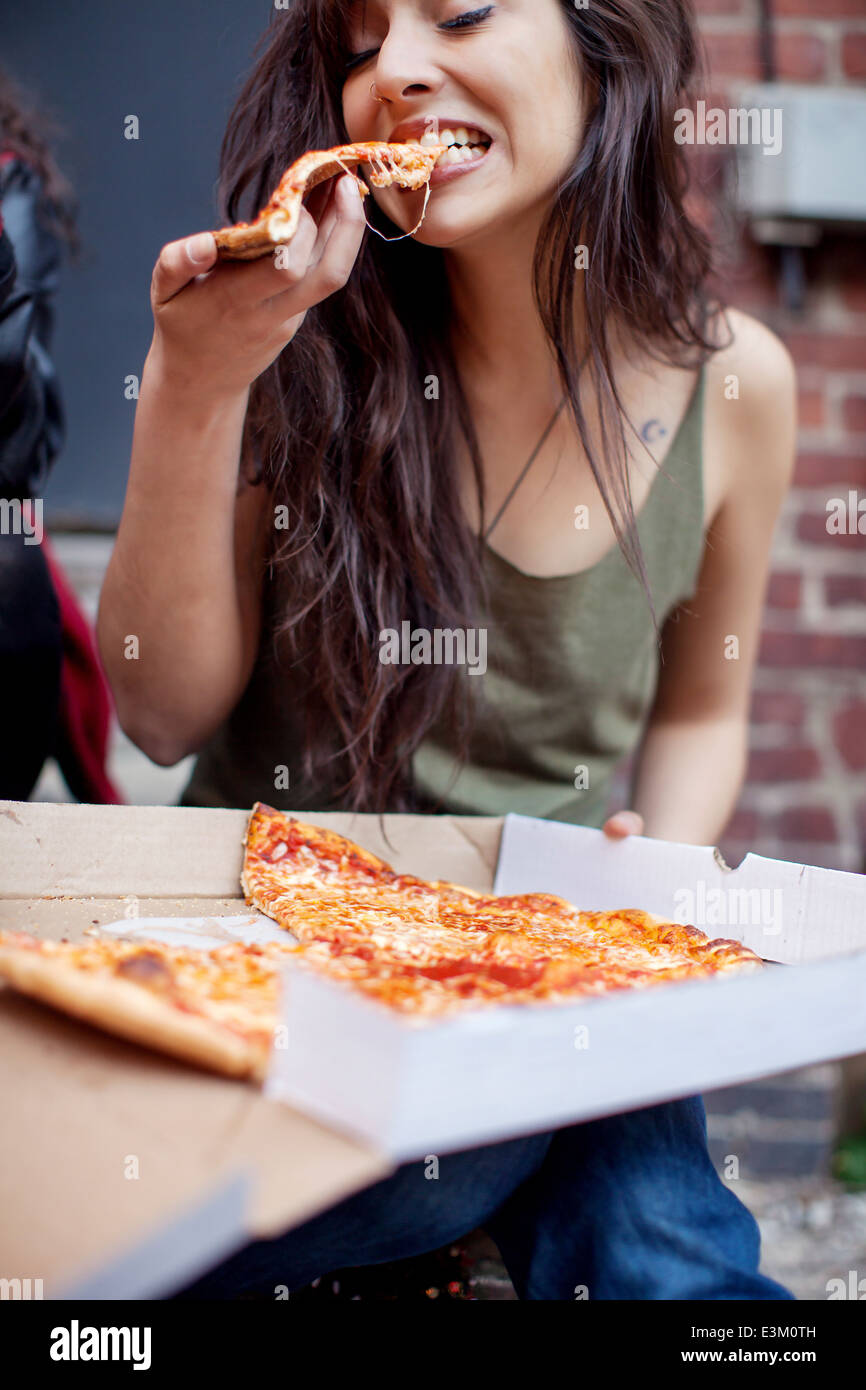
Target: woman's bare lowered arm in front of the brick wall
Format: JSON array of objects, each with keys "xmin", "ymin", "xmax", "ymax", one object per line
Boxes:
[{"xmin": 605, "ymin": 314, "xmax": 796, "ymax": 845}]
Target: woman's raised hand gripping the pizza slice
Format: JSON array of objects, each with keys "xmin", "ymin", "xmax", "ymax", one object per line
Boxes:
[{"xmin": 150, "ymin": 175, "xmax": 366, "ymax": 399}]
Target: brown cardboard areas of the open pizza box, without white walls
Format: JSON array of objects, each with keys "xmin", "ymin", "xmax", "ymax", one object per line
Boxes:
[{"xmin": 0, "ymin": 801, "xmax": 500, "ymax": 1298}]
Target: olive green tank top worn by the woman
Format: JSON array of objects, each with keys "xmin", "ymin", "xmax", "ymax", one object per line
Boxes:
[{"xmin": 181, "ymin": 370, "xmax": 705, "ymax": 826}]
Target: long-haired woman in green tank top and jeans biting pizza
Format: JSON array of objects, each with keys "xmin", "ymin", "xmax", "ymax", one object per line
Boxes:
[{"xmin": 99, "ymin": 0, "xmax": 794, "ymax": 1298}]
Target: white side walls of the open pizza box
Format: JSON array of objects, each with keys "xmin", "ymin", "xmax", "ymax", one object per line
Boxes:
[{"xmin": 265, "ymin": 815, "xmax": 866, "ymax": 1159}]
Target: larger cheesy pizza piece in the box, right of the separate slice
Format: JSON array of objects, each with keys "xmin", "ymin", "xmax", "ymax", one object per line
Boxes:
[{"xmin": 242, "ymin": 808, "xmax": 760, "ymax": 1016}]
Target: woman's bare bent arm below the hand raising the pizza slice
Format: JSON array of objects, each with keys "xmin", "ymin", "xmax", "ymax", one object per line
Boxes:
[{"xmin": 97, "ymin": 349, "xmax": 264, "ymax": 766}]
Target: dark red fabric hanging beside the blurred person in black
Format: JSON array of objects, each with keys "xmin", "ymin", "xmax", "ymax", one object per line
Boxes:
[{"xmin": 42, "ymin": 538, "xmax": 124, "ymax": 806}]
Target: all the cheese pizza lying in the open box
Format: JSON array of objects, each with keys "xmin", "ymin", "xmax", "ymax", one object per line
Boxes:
[{"xmin": 0, "ymin": 802, "xmax": 762, "ymax": 1081}]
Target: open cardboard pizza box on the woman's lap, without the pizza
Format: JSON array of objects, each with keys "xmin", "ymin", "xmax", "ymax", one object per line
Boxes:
[{"xmin": 0, "ymin": 802, "xmax": 866, "ymax": 1298}]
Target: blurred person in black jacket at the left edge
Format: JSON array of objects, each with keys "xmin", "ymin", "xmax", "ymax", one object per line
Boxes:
[{"xmin": 0, "ymin": 70, "xmax": 118, "ymax": 802}]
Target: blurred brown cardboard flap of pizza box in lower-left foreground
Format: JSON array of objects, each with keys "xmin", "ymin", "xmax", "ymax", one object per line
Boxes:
[{"xmin": 0, "ymin": 990, "xmax": 389, "ymax": 1298}]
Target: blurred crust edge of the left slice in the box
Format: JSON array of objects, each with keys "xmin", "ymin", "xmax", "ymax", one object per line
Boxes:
[{"xmin": 0, "ymin": 945, "xmax": 268, "ymax": 1081}]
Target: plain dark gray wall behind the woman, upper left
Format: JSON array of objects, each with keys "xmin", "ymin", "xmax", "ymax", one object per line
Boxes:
[{"xmin": 0, "ymin": 0, "xmax": 272, "ymax": 525}]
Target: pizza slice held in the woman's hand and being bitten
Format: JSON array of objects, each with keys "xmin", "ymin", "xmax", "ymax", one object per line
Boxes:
[{"xmin": 214, "ymin": 140, "xmax": 445, "ymax": 260}]
